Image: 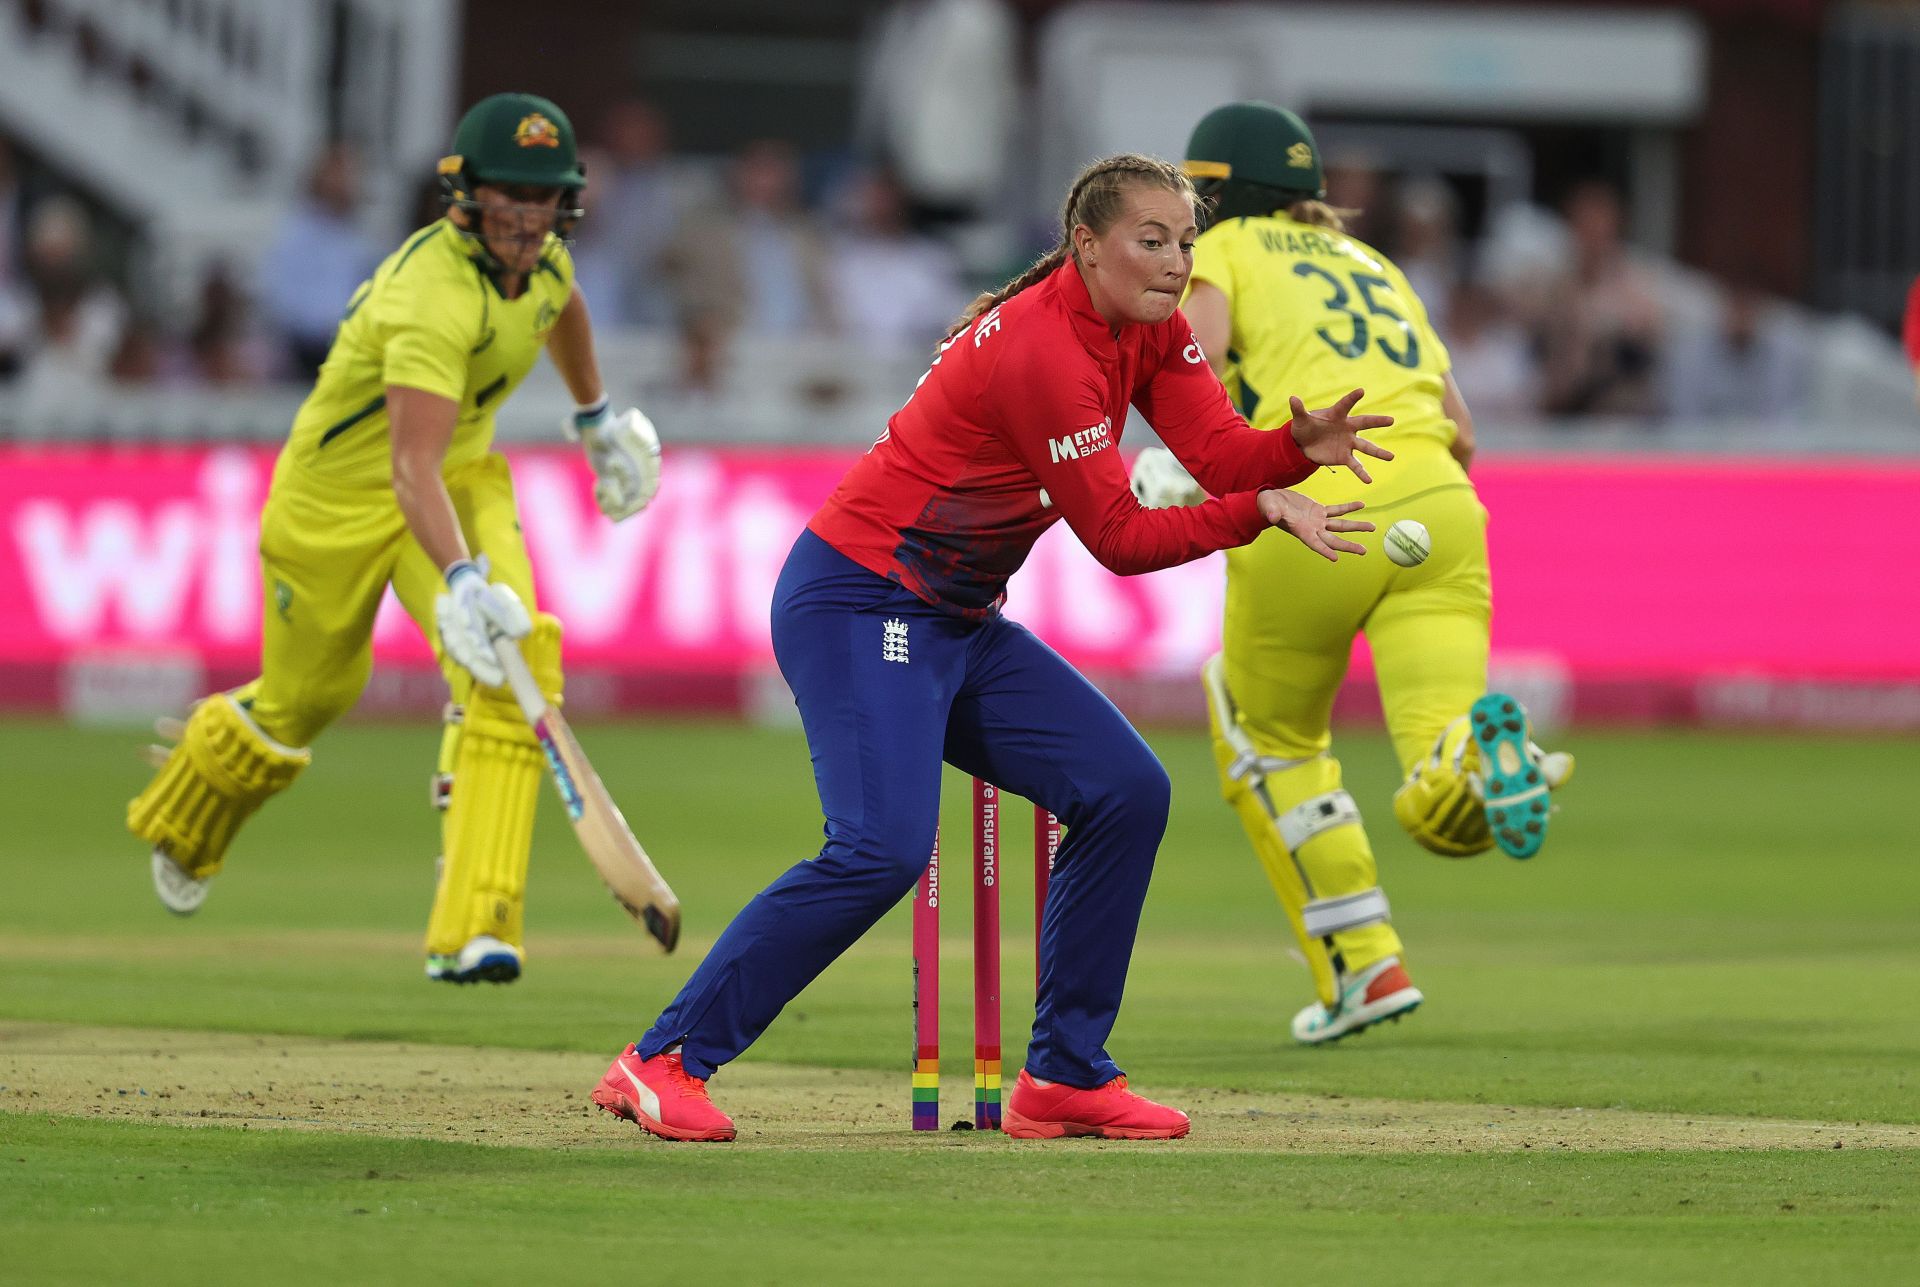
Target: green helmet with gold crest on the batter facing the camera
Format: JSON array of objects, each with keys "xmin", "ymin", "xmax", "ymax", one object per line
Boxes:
[{"xmin": 440, "ymin": 94, "xmax": 588, "ymax": 236}]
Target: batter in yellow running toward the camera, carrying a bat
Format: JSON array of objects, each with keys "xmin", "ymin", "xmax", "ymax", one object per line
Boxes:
[{"xmin": 127, "ymin": 94, "xmax": 678, "ymax": 983}]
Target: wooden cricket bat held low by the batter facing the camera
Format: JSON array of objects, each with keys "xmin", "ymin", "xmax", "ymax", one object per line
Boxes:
[{"xmin": 493, "ymin": 636, "xmax": 680, "ymax": 951}]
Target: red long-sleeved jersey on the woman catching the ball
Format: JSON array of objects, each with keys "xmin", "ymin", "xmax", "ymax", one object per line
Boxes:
[{"xmin": 808, "ymin": 259, "xmax": 1315, "ymax": 617}]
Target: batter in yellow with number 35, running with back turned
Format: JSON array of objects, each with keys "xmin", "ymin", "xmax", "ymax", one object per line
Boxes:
[{"xmin": 1137, "ymin": 104, "xmax": 1571, "ymax": 1043}]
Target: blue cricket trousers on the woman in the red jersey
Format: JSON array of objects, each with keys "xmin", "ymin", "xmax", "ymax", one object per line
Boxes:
[{"xmin": 639, "ymin": 532, "xmax": 1171, "ymax": 1087}]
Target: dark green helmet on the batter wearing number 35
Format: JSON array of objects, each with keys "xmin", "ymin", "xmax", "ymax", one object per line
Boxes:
[{"xmin": 1185, "ymin": 102, "xmax": 1327, "ymax": 219}]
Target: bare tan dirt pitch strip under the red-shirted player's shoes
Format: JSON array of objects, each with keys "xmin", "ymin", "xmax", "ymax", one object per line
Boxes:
[{"xmin": 0, "ymin": 1022, "xmax": 1920, "ymax": 1153}]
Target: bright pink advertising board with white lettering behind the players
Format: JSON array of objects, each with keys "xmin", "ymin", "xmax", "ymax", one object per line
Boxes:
[{"xmin": 0, "ymin": 448, "xmax": 1920, "ymax": 726}]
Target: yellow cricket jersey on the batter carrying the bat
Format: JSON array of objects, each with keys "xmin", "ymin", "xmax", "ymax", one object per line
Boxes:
[{"xmin": 280, "ymin": 219, "xmax": 574, "ymax": 490}]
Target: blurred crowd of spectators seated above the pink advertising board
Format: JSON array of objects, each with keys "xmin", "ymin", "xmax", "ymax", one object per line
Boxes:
[{"xmin": 0, "ymin": 102, "xmax": 1811, "ymax": 423}]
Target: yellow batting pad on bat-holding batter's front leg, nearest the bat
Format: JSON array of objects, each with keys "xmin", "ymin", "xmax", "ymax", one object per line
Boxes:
[{"xmin": 426, "ymin": 613, "xmax": 561, "ymax": 955}]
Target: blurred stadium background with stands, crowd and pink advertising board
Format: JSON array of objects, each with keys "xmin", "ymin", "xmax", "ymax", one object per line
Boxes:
[{"xmin": 0, "ymin": 0, "xmax": 1920, "ymax": 728}]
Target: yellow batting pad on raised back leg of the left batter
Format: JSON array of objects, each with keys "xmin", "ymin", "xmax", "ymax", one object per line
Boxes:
[{"xmin": 127, "ymin": 693, "xmax": 313, "ymax": 878}]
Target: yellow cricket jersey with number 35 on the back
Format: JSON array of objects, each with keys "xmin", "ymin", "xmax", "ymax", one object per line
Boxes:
[{"xmin": 1192, "ymin": 213, "xmax": 1465, "ymax": 501}]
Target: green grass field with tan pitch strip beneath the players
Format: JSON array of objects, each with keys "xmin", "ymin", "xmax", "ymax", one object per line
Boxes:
[{"xmin": 0, "ymin": 722, "xmax": 1920, "ymax": 1283}]
